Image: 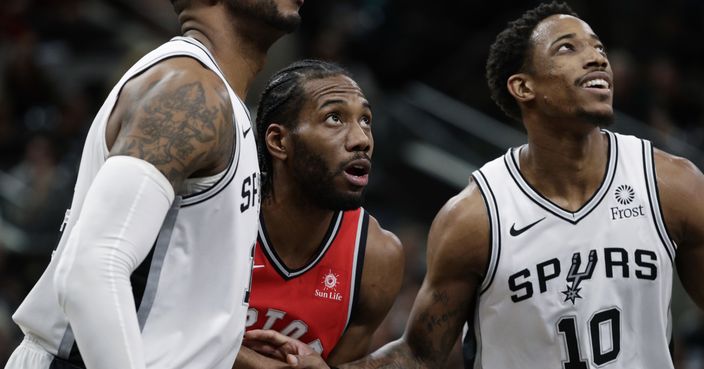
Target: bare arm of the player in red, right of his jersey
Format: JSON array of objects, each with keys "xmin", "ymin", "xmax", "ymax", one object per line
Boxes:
[{"xmin": 328, "ymin": 217, "xmax": 405, "ymax": 364}]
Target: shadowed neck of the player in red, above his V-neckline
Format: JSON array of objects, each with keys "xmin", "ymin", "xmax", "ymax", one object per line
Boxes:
[{"xmin": 262, "ymin": 183, "xmax": 335, "ymax": 269}]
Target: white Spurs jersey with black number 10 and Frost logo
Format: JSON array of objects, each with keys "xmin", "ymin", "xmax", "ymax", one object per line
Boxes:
[{"xmin": 464, "ymin": 131, "xmax": 676, "ymax": 369}]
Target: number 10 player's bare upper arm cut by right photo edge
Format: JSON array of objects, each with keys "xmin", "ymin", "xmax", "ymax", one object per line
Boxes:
[{"xmin": 655, "ymin": 150, "xmax": 704, "ymax": 309}]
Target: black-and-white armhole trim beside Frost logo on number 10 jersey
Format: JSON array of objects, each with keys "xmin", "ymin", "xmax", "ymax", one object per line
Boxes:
[{"xmin": 641, "ymin": 140, "xmax": 676, "ymax": 263}]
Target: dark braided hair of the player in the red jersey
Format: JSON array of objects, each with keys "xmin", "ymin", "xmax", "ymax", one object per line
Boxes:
[{"xmin": 255, "ymin": 59, "xmax": 352, "ymax": 198}]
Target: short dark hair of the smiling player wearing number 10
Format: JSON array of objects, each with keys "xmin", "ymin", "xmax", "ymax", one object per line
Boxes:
[{"xmin": 486, "ymin": 1, "xmax": 578, "ymax": 121}]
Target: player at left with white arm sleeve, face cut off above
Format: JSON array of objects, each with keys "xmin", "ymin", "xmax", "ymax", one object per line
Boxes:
[{"xmin": 6, "ymin": 0, "xmax": 302, "ymax": 369}]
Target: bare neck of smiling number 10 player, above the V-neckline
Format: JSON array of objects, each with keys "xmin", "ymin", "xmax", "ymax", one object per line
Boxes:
[{"xmin": 520, "ymin": 115, "xmax": 608, "ymax": 211}]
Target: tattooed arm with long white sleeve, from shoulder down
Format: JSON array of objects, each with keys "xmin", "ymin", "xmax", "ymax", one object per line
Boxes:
[{"xmin": 54, "ymin": 58, "xmax": 234, "ymax": 369}]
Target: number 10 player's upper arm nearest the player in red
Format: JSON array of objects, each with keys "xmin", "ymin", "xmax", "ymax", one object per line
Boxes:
[{"xmin": 404, "ymin": 183, "xmax": 490, "ymax": 367}]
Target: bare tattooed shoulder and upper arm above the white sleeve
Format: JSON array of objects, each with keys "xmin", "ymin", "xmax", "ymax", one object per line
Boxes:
[{"xmin": 106, "ymin": 57, "xmax": 234, "ymax": 189}]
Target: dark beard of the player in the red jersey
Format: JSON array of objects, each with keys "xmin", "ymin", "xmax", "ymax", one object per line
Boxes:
[{"xmin": 293, "ymin": 136, "xmax": 365, "ymax": 211}]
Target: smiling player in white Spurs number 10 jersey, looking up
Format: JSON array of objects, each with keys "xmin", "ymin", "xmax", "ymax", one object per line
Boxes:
[{"xmin": 246, "ymin": 3, "xmax": 704, "ymax": 369}]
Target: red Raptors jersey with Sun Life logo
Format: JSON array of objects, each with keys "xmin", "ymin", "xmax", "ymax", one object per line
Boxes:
[{"xmin": 247, "ymin": 208, "xmax": 369, "ymax": 358}]
